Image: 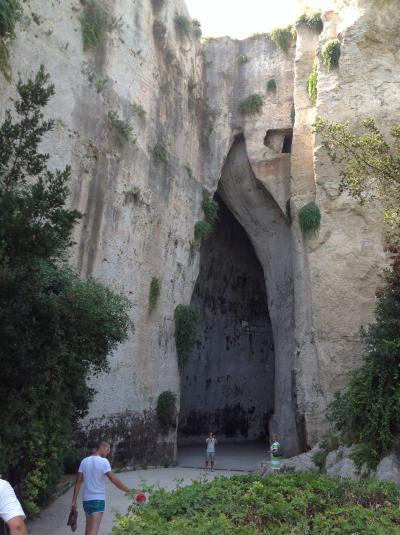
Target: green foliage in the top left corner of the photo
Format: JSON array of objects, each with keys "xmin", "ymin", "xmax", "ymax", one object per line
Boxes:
[{"xmin": 0, "ymin": 0, "xmax": 22, "ymax": 81}]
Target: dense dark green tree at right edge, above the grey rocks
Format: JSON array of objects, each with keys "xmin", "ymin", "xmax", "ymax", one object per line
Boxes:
[{"xmin": 330, "ymin": 258, "xmax": 400, "ymax": 468}]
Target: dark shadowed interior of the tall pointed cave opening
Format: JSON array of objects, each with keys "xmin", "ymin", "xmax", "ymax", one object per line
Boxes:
[{"xmin": 178, "ymin": 193, "xmax": 274, "ymax": 451}]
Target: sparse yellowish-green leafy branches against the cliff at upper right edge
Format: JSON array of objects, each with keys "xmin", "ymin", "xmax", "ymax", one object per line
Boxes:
[{"xmin": 315, "ymin": 117, "xmax": 400, "ymax": 244}]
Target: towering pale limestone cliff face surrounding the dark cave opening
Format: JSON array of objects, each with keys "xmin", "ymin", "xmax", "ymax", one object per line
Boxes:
[{"xmin": 0, "ymin": 0, "xmax": 400, "ymax": 464}]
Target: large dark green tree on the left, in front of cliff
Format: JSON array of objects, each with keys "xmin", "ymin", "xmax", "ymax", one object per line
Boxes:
[{"xmin": 0, "ymin": 67, "xmax": 131, "ymax": 513}]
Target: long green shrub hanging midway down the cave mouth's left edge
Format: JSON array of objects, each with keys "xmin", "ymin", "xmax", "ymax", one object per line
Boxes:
[{"xmin": 174, "ymin": 305, "xmax": 200, "ymax": 372}]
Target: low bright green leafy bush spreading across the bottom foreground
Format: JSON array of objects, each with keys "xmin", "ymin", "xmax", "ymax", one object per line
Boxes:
[{"xmin": 112, "ymin": 473, "xmax": 400, "ymax": 535}]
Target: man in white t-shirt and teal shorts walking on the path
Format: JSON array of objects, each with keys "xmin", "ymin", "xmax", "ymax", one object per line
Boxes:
[{"xmin": 72, "ymin": 441, "xmax": 131, "ymax": 535}]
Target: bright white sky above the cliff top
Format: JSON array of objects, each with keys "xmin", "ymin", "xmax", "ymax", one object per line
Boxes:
[{"xmin": 186, "ymin": 0, "xmax": 324, "ymax": 39}]
